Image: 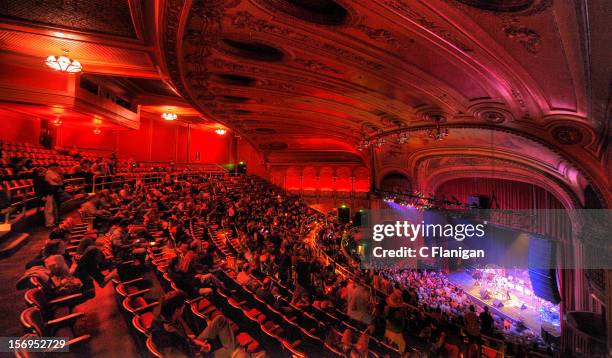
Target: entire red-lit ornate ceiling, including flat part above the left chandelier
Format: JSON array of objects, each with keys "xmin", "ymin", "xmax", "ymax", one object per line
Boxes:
[{"xmin": 0, "ymin": 0, "xmax": 612, "ymax": 203}]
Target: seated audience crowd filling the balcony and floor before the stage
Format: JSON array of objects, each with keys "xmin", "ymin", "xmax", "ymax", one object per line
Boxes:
[{"xmin": 11, "ymin": 161, "xmax": 552, "ymax": 357}]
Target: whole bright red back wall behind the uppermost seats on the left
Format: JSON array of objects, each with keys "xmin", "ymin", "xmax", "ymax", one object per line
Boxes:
[{"xmin": 0, "ymin": 108, "xmax": 233, "ymax": 165}]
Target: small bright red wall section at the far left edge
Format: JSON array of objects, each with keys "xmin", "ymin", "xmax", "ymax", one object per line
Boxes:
[{"xmin": 0, "ymin": 108, "xmax": 40, "ymax": 144}]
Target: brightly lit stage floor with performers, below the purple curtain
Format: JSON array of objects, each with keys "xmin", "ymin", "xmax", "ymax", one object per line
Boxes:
[{"xmin": 448, "ymin": 272, "xmax": 542, "ymax": 335}]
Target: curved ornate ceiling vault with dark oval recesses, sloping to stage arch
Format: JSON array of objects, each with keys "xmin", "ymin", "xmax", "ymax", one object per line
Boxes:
[{"xmin": 161, "ymin": 0, "xmax": 612, "ymax": 206}]
